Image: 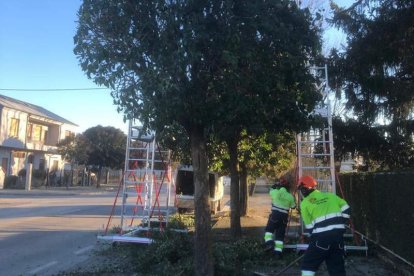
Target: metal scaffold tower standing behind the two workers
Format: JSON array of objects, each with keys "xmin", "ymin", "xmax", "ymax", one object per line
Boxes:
[{"xmin": 285, "ymin": 65, "xmax": 368, "ymax": 253}]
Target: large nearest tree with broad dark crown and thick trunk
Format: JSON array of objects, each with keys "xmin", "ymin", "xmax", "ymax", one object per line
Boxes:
[{"xmin": 75, "ymin": 0, "xmax": 318, "ymax": 275}]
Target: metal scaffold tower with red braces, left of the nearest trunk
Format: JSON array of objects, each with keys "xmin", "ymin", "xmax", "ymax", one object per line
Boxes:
[{"xmin": 98, "ymin": 120, "xmax": 176, "ymax": 243}]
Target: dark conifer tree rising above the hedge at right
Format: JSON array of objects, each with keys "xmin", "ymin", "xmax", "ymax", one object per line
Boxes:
[{"xmin": 330, "ymin": 0, "xmax": 414, "ymax": 168}]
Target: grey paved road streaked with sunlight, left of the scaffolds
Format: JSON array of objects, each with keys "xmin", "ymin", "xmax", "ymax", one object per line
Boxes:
[{"xmin": 0, "ymin": 188, "xmax": 119, "ymax": 276}]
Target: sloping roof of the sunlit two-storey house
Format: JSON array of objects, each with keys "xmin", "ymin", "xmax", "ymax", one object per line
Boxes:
[{"xmin": 0, "ymin": 95, "xmax": 78, "ymax": 126}]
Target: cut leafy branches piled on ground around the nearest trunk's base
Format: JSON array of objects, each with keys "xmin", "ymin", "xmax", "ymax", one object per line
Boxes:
[{"xmin": 131, "ymin": 231, "xmax": 278, "ymax": 276}]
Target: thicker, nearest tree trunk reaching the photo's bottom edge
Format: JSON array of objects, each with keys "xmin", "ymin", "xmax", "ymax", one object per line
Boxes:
[{"xmin": 190, "ymin": 128, "xmax": 214, "ymax": 276}]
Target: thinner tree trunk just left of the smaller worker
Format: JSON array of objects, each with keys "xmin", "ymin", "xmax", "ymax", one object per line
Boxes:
[{"xmin": 227, "ymin": 139, "xmax": 241, "ymax": 238}]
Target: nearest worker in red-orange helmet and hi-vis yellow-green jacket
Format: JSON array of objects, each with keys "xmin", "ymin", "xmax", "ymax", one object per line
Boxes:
[{"xmin": 298, "ymin": 175, "xmax": 350, "ymax": 276}]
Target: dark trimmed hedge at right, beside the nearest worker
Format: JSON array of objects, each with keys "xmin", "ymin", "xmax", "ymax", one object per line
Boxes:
[{"xmin": 338, "ymin": 172, "xmax": 414, "ymax": 262}]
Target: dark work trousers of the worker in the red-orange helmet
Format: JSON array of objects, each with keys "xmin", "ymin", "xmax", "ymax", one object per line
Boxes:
[{"xmin": 301, "ymin": 230, "xmax": 346, "ymax": 276}]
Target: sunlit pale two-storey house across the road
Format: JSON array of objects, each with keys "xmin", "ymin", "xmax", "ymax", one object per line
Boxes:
[{"xmin": 0, "ymin": 95, "xmax": 77, "ymax": 188}]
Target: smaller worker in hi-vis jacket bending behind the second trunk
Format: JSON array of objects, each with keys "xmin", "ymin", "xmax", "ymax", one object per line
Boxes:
[{"xmin": 264, "ymin": 178, "xmax": 296, "ymax": 258}]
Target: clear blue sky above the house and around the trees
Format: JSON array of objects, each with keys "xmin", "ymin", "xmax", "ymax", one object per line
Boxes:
[{"xmin": 0, "ymin": 0, "xmax": 353, "ymax": 132}]
